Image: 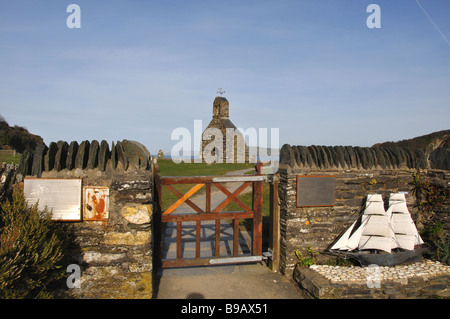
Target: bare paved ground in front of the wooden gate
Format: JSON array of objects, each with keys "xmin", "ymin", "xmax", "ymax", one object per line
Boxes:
[{"xmin": 154, "ymin": 263, "xmax": 303, "ymax": 299}]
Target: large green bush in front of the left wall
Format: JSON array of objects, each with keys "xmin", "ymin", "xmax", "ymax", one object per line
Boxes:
[{"xmin": 0, "ymin": 189, "xmax": 70, "ymax": 299}]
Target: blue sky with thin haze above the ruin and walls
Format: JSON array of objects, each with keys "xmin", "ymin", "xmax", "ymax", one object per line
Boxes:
[{"xmin": 0, "ymin": 0, "xmax": 450, "ymax": 154}]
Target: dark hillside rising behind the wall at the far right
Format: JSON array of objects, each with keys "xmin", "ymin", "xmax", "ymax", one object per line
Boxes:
[{"xmin": 372, "ymin": 130, "xmax": 450, "ymax": 155}]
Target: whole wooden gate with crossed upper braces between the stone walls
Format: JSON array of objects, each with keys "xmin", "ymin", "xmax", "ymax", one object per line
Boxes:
[{"xmin": 154, "ymin": 163, "xmax": 264, "ymax": 268}]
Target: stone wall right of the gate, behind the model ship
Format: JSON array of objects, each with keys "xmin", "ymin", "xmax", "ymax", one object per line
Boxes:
[{"xmin": 278, "ymin": 145, "xmax": 450, "ymax": 274}]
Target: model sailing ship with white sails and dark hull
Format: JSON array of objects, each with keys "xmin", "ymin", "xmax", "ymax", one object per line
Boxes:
[{"xmin": 330, "ymin": 193, "xmax": 426, "ymax": 266}]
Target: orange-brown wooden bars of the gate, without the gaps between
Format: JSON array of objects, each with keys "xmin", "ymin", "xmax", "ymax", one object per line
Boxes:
[{"xmin": 154, "ymin": 163, "xmax": 264, "ymax": 268}]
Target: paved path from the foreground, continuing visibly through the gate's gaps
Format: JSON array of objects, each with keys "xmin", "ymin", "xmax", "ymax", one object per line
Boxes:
[{"xmin": 154, "ymin": 170, "xmax": 303, "ymax": 299}]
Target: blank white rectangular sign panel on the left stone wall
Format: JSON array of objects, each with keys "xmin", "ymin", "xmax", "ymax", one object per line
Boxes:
[{"xmin": 23, "ymin": 178, "xmax": 81, "ymax": 221}]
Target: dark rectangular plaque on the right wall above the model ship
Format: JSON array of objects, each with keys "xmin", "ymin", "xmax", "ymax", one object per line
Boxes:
[{"xmin": 297, "ymin": 175, "xmax": 336, "ymax": 207}]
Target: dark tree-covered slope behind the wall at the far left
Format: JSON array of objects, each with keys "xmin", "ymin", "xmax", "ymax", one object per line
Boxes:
[{"xmin": 0, "ymin": 115, "xmax": 44, "ymax": 153}]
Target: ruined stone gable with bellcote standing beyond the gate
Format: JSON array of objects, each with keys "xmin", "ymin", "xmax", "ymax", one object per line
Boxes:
[{"xmin": 201, "ymin": 96, "xmax": 248, "ymax": 163}]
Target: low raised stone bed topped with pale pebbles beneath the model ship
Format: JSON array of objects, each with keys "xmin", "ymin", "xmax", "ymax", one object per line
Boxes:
[{"xmin": 294, "ymin": 260, "xmax": 450, "ymax": 299}]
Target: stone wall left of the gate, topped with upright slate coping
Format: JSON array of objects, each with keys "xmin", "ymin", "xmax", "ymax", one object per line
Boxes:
[{"xmin": 15, "ymin": 140, "xmax": 153, "ymax": 299}]
